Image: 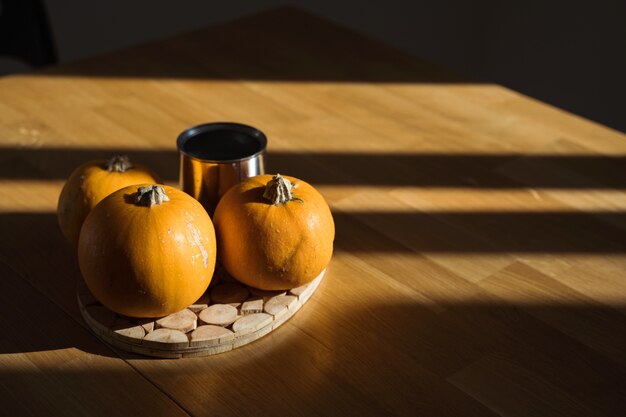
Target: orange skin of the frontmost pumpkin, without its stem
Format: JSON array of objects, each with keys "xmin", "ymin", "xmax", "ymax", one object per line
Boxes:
[{"xmin": 78, "ymin": 185, "xmax": 216, "ymax": 317}]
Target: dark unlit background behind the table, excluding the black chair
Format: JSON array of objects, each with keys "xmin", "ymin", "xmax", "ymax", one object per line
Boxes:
[{"xmin": 0, "ymin": 0, "xmax": 626, "ymax": 131}]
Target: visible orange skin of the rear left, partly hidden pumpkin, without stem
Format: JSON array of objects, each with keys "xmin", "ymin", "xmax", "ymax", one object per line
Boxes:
[{"xmin": 57, "ymin": 159, "xmax": 160, "ymax": 245}]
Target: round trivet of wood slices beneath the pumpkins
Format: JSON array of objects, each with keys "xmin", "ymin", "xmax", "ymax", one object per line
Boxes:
[{"xmin": 77, "ymin": 268, "xmax": 326, "ymax": 358}]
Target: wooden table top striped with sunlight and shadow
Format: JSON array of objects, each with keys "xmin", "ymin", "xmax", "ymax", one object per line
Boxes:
[{"xmin": 0, "ymin": 9, "xmax": 626, "ymax": 417}]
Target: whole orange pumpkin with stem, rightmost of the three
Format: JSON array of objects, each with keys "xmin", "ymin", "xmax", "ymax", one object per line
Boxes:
[{"xmin": 213, "ymin": 174, "xmax": 335, "ymax": 290}]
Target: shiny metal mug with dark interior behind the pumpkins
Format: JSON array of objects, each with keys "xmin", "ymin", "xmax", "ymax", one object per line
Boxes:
[{"xmin": 176, "ymin": 122, "xmax": 267, "ymax": 216}]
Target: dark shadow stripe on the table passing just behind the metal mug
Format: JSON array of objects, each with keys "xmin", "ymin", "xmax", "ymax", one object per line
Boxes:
[{"xmin": 0, "ymin": 145, "xmax": 626, "ymax": 189}]
